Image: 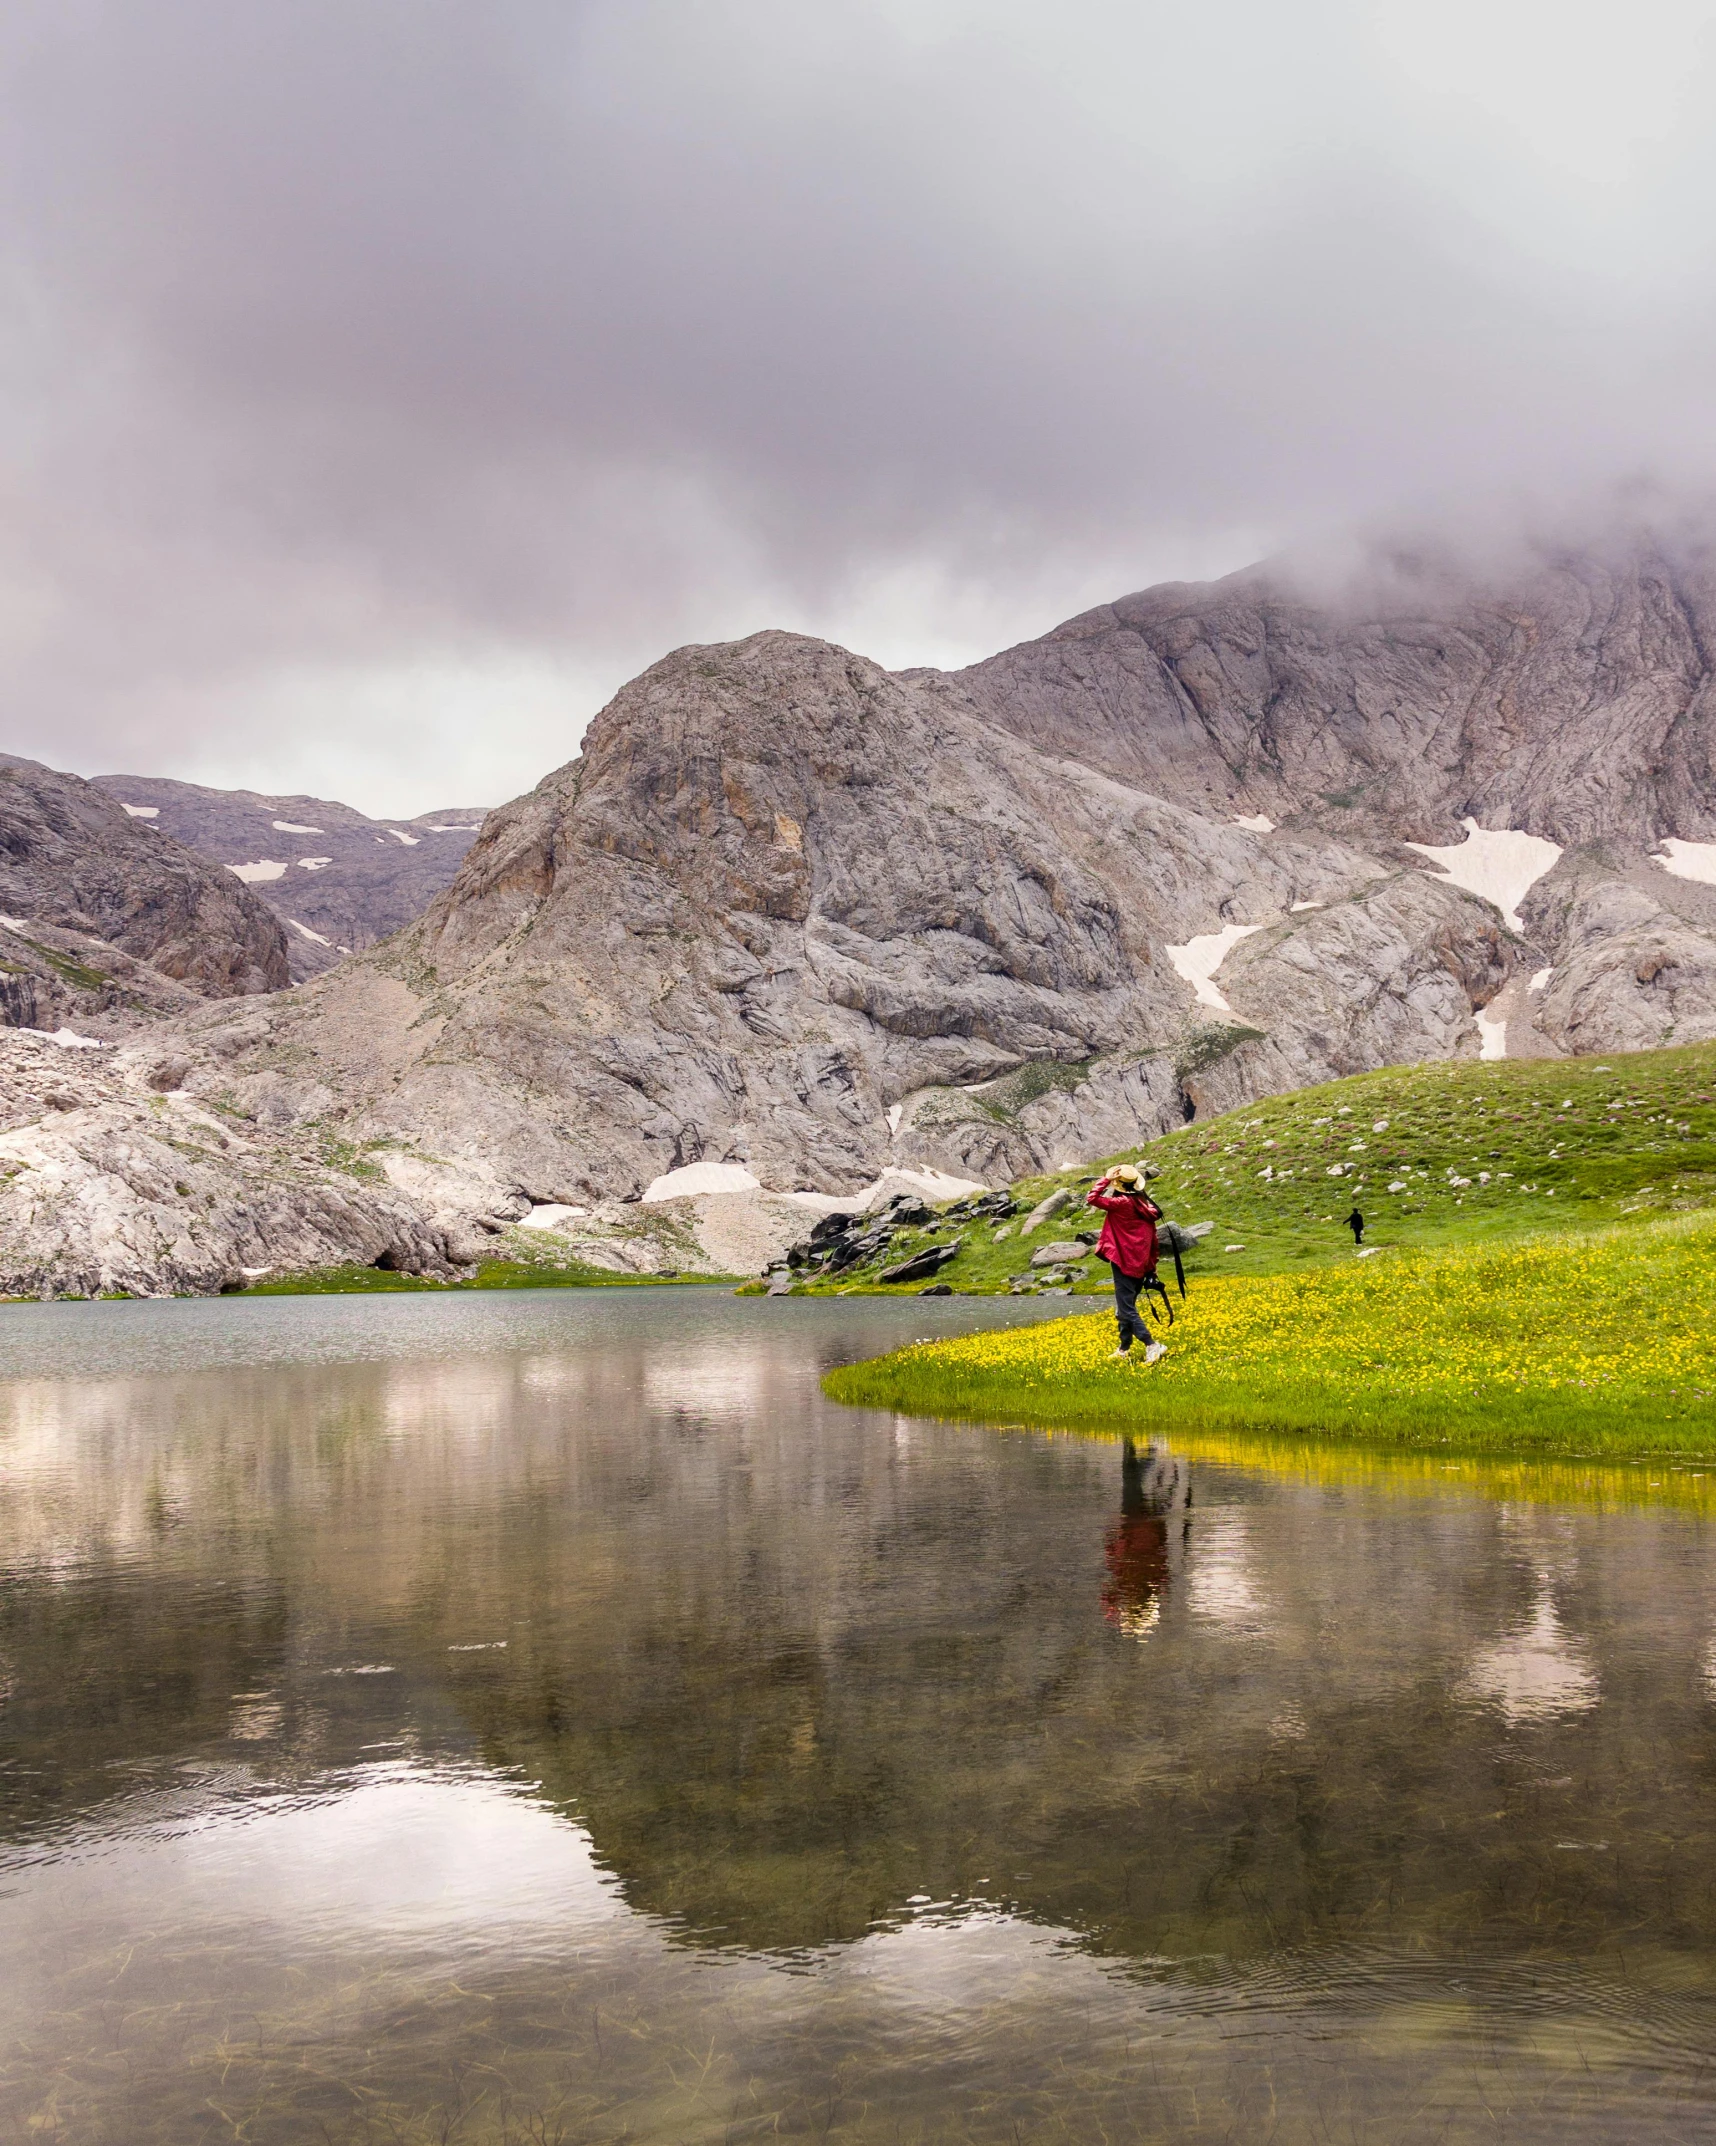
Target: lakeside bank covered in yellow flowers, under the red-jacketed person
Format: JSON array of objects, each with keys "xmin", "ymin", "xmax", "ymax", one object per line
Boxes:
[{"xmin": 824, "ymin": 1215, "xmax": 1716, "ymax": 1459}]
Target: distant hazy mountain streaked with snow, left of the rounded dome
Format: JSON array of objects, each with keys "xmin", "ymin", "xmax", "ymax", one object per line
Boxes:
[{"xmin": 97, "ymin": 775, "xmax": 483, "ymax": 979}]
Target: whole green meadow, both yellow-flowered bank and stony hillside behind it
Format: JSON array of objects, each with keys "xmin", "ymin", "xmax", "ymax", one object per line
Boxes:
[{"xmin": 826, "ymin": 1045, "xmax": 1716, "ymax": 1466}]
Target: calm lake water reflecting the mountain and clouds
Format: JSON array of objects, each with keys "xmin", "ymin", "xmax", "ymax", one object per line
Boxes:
[{"xmin": 0, "ymin": 1290, "xmax": 1716, "ymax": 2146}]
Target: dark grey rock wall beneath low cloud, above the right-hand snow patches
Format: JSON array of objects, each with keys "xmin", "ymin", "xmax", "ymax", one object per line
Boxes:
[{"xmin": 955, "ymin": 543, "xmax": 1716, "ymax": 852}]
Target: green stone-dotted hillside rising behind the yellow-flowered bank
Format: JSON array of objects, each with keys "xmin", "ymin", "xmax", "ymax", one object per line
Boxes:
[{"xmin": 789, "ymin": 1043, "xmax": 1716, "ymax": 1294}]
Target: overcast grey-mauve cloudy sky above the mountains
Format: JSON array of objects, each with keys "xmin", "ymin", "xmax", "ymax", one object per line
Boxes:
[{"xmin": 0, "ymin": 0, "xmax": 1716, "ymax": 813}]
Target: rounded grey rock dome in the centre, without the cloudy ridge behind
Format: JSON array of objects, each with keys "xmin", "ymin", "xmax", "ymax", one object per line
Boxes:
[{"xmin": 190, "ymin": 633, "xmax": 1508, "ymax": 1215}]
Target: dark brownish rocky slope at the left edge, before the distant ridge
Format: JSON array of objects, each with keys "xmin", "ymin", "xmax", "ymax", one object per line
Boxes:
[{"xmin": 0, "ymin": 758, "xmax": 290, "ymax": 1028}]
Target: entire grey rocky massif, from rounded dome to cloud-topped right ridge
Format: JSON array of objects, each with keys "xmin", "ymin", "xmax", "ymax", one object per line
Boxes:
[{"xmin": 19, "ymin": 530, "xmax": 1716, "ymax": 1266}]
